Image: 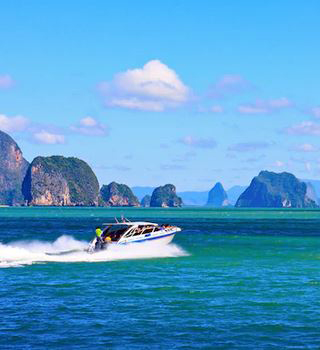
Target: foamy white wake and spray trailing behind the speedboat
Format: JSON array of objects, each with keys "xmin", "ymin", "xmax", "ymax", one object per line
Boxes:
[{"xmin": 0, "ymin": 235, "xmax": 188, "ymax": 268}]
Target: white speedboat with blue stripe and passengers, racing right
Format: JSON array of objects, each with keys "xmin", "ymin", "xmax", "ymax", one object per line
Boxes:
[{"xmin": 87, "ymin": 219, "xmax": 181, "ymax": 253}]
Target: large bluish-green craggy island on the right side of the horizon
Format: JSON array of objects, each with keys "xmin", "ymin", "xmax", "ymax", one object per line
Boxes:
[{"xmin": 236, "ymin": 171, "xmax": 317, "ymax": 208}]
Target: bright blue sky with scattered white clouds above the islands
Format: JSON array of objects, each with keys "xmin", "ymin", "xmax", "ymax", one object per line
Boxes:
[{"xmin": 0, "ymin": 0, "xmax": 320, "ymax": 191}]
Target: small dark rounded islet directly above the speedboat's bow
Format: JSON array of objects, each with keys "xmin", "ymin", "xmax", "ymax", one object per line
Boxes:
[{"xmin": 150, "ymin": 184, "xmax": 183, "ymax": 208}]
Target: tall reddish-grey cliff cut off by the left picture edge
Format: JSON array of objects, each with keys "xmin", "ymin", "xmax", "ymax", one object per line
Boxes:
[{"xmin": 0, "ymin": 131, "xmax": 29, "ymax": 205}]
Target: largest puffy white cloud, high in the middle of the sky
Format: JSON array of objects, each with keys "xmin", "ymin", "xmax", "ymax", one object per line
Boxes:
[{"xmin": 99, "ymin": 60, "xmax": 190, "ymax": 111}]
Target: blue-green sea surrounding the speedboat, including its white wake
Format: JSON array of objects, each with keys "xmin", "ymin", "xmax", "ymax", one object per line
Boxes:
[{"xmin": 0, "ymin": 208, "xmax": 320, "ymax": 349}]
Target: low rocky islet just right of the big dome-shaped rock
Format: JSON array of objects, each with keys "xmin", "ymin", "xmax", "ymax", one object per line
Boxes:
[{"xmin": 100, "ymin": 182, "xmax": 140, "ymax": 207}]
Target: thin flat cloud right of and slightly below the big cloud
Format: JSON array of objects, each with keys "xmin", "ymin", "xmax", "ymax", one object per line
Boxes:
[{"xmin": 237, "ymin": 97, "xmax": 293, "ymax": 114}]
